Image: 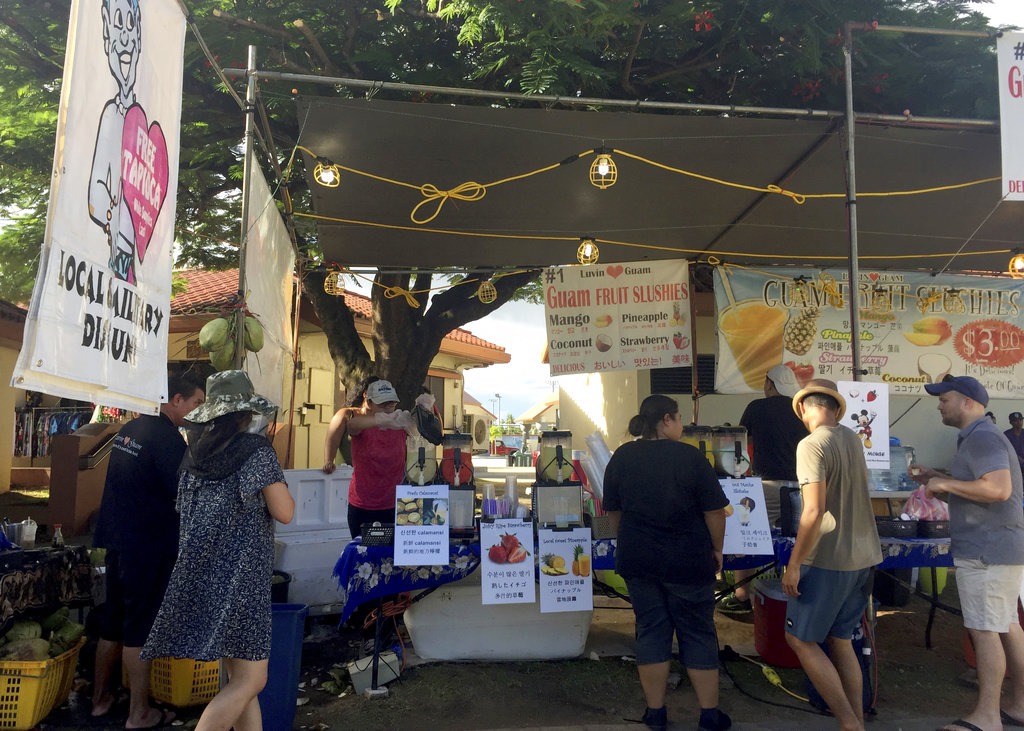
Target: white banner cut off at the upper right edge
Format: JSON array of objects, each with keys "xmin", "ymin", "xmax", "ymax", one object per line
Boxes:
[{"xmin": 995, "ymin": 33, "xmax": 1024, "ymax": 201}]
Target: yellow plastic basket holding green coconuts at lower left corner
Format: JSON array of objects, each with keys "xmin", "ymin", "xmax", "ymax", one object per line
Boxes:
[{"xmin": 0, "ymin": 637, "xmax": 85, "ymax": 731}]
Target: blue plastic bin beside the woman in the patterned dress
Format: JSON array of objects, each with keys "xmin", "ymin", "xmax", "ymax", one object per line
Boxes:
[{"xmin": 258, "ymin": 604, "xmax": 309, "ymax": 731}]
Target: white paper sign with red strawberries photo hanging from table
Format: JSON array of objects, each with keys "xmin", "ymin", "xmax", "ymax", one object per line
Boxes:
[{"xmin": 480, "ymin": 519, "xmax": 537, "ymax": 604}]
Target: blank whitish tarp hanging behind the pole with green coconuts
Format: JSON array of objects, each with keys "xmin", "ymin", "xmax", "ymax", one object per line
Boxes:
[{"xmin": 246, "ymin": 165, "xmax": 295, "ymax": 412}]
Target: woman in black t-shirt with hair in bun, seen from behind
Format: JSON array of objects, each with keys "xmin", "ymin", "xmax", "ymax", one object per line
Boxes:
[{"xmin": 604, "ymin": 394, "xmax": 732, "ymax": 731}]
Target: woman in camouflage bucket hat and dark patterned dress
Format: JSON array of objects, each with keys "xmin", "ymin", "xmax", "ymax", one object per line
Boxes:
[{"xmin": 141, "ymin": 371, "xmax": 295, "ymax": 731}]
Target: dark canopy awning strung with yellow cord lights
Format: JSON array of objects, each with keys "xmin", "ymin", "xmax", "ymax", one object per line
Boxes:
[{"xmin": 299, "ymin": 97, "xmax": 1024, "ymax": 272}]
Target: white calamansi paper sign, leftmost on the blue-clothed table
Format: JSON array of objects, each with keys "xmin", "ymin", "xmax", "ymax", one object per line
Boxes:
[{"xmin": 394, "ymin": 485, "xmax": 449, "ymax": 566}]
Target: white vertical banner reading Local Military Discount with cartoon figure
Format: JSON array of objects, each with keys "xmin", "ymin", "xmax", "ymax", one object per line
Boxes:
[{"xmin": 11, "ymin": 0, "xmax": 185, "ymax": 414}]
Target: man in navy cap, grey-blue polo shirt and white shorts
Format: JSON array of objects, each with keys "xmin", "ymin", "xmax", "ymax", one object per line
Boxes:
[{"xmin": 910, "ymin": 376, "xmax": 1024, "ymax": 731}]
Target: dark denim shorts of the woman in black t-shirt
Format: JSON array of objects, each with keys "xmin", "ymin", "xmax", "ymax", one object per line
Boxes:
[{"xmin": 626, "ymin": 578, "xmax": 718, "ymax": 670}]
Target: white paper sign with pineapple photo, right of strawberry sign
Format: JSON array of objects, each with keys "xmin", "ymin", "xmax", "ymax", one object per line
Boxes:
[{"xmin": 537, "ymin": 528, "xmax": 594, "ymax": 614}]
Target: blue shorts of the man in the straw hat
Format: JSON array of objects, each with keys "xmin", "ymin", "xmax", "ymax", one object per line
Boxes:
[{"xmin": 785, "ymin": 565, "xmax": 871, "ymax": 642}]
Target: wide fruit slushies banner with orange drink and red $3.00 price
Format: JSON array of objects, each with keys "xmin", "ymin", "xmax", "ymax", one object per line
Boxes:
[{"xmin": 715, "ymin": 266, "xmax": 1024, "ymax": 398}]
